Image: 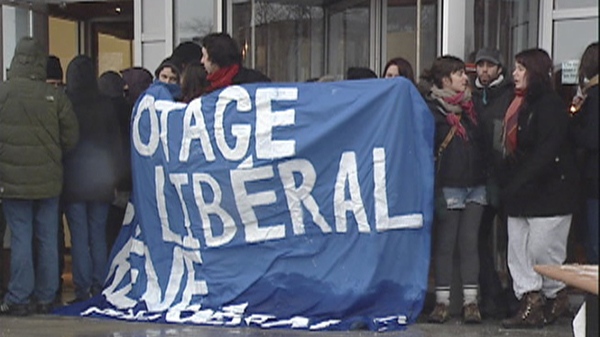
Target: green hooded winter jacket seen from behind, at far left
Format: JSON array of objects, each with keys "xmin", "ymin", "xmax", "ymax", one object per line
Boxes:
[{"xmin": 0, "ymin": 37, "xmax": 79, "ymax": 200}]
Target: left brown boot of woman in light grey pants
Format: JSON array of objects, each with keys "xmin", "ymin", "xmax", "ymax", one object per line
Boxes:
[{"xmin": 502, "ymin": 291, "xmax": 544, "ymax": 329}]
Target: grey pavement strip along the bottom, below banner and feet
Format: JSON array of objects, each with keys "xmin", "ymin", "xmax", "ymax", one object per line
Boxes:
[{"xmin": 0, "ymin": 315, "xmax": 573, "ymax": 337}]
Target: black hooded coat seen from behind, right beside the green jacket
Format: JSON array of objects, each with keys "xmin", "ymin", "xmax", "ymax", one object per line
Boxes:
[{"xmin": 63, "ymin": 56, "xmax": 123, "ymax": 203}]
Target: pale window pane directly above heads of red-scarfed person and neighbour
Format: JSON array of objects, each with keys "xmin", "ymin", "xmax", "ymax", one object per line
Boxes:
[{"xmin": 174, "ymin": 0, "xmax": 216, "ymax": 45}]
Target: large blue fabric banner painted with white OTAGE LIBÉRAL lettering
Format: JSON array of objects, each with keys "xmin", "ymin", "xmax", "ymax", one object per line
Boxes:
[{"xmin": 72, "ymin": 78, "xmax": 434, "ymax": 331}]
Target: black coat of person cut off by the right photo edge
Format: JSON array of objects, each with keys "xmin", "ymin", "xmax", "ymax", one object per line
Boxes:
[{"xmin": 571, "ymin": 85, "xmax": 600, "ymax": 199}]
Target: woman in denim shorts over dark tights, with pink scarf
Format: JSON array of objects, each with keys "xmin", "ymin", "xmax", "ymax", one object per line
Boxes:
[{"xmin": 420, "ymin": 56, "xmax": 486, "ymax": 323}]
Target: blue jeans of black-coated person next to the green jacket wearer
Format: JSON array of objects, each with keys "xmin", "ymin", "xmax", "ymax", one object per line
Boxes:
[{"xmin": 65, "ymin": 202, "xmax": 110, "ymax": 299}]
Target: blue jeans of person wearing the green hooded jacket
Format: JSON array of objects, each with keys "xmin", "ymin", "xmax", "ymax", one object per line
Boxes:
[{"xmin": 2, "ymin": 198, "xmax": 58, "ymax": 304}]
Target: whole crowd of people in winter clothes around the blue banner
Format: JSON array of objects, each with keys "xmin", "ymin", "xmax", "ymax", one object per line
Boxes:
[{"xmin": 0, "ymin": 33, "xmax": 599, "ymax": 328}]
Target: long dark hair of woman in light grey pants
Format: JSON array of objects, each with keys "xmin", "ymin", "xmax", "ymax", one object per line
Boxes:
[{"xmin": 515, "ymin": 48, "xmax": 552, "ymax": 98}]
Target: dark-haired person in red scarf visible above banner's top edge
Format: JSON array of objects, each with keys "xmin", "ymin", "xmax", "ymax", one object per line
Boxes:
[{"xmin": 200, "ymin": 33, "xmax": 271, "ymax": 93}]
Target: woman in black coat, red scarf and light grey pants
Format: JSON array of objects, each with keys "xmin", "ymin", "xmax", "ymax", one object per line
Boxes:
[{"xmin": 499, "ymin": 49, "xmax": 578, "ymax": 329}]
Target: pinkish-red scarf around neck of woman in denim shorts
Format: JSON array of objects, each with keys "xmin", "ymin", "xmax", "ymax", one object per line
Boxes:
[{"xmin": 431, "ymin": 85, "xmax": 477, "ymax": 140}]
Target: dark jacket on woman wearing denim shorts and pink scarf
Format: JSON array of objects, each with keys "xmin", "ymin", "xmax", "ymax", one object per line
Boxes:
[{"xmin": 427, "ymin": 99, "xmax": 485, "ymax": 188}]
